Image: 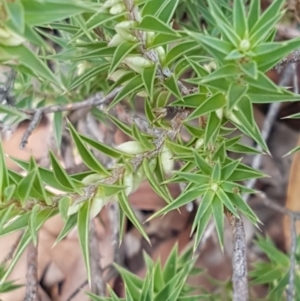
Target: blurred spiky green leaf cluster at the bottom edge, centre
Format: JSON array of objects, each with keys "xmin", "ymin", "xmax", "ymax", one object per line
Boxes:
[{"xmin": 89, "ymin": 248, "xmax": 208, "ymax": 301}]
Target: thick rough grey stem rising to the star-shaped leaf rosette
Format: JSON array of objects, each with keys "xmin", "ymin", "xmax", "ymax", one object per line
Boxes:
[{"xmin": 226, "ymin": 211, "xmax": 249, "ymax": 301}]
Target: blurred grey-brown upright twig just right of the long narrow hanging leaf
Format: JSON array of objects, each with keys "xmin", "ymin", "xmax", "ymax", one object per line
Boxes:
[{"xmin": 89, "ymin": 221, "xmax": 106, "ymax": 297}]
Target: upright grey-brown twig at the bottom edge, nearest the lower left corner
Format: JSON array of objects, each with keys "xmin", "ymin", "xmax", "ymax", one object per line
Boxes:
[{"xmin": 24, "ymin": 242, "xmax": 39, "ymax": 301}]
